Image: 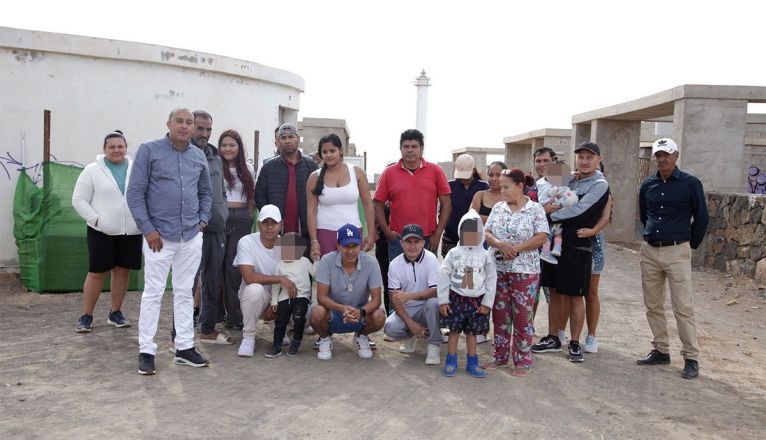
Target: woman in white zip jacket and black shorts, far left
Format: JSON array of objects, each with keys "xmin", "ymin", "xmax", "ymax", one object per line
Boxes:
[{"xmin": 72, "ymin": 130, "xmax": 143, "ymax": 333}]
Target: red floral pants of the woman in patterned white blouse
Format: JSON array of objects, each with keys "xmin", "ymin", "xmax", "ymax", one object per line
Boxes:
[{"xmin": 492, "ymin": 272, "xmax": 539, "ymax": 368}]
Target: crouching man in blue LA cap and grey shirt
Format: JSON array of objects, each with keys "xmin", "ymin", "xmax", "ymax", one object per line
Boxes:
[{"xmin": 311, "ymin": 224, "xmax": 386, "ymax": 361}]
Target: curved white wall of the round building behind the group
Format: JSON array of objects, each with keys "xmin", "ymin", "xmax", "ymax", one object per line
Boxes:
[{"xmin": 0, "ymin": 27, "xmax": 304, "ymax": 269}]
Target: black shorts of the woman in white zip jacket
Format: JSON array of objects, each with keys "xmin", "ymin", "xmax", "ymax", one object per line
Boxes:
[{"xmin": 88, "ymin": 226, "xmax": 144, "ymax": 273}]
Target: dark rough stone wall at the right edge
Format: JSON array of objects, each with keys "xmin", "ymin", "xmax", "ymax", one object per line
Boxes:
[{"xmin": 695, "ymin": 192, "xmax": 766, "ymax": 283}]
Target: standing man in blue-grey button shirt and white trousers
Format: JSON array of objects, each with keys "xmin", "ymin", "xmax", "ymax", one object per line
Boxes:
[{"xmin": 126, "ymin": 109, "xmax": 212, "ymax": 374}]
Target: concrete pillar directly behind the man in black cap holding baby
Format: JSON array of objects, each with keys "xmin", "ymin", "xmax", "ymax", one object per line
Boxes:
[{"xmin": 591, "ymin": 119, "xmax": 641, "ymax": 242}]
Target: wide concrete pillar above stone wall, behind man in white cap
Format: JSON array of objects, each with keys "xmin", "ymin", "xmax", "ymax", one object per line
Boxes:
[{"xmin": 673, "ymin": 99, "xmax": 747, "ymax": 192}]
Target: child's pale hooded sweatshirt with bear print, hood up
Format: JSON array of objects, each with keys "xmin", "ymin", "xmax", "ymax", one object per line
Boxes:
[{"xmin": 436, "ymin": 209, "xmax": 497, "ymax": 309}]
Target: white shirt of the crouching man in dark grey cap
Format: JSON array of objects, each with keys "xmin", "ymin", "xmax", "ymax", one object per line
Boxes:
[{"xmin": 388, "ymin": 249, "xmax": 440, "ymax": 306}]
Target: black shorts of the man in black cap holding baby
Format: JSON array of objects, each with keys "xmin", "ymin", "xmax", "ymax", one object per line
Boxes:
[{"xmin": 540, "ymin": 248, "xmax": 593, "ymax": 296}]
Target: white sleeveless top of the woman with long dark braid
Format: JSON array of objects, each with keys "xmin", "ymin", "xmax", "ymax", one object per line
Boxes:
[{"xmin": 317, "ymin": 164, "xmax": 362, "ymax": 231}]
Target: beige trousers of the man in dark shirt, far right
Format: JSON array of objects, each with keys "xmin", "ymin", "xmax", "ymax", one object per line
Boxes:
[{"xmin": 639, "ymin": 242, "xmax": 699, "ymax": 360}]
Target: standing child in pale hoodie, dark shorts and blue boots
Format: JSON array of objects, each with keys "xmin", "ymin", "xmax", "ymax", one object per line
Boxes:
[{"xmin": 437, "ymin": 209, "xmax": 497, "ymax": 377}]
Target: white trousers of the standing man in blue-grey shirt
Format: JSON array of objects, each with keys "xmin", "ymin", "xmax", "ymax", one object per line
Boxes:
[{"xmin": 138, "ymin": 232, "xmax": 202, "ymax": 355}]
